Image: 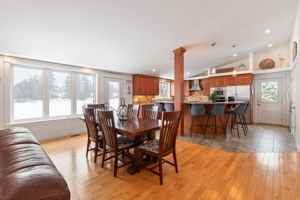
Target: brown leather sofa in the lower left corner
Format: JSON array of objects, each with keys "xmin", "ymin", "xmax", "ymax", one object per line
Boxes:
[{"xmin": 0, "ymin": 128, "xmax": 70, "ymax": 200}]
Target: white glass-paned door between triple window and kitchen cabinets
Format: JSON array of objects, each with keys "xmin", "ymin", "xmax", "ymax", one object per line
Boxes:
[{"xmin": 104, "ymin": 78, "xmax": 123, "ymax": 110}]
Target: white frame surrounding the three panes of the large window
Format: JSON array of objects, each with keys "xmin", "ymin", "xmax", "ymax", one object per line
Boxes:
[{"xmin": 6, "ymin": 63, "xmax": 98, "ymax": 124}]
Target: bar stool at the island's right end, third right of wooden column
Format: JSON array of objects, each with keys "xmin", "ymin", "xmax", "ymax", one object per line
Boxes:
[{"xmin": 226, "ymin": 103, "xmax": 249, "ymax": 137}]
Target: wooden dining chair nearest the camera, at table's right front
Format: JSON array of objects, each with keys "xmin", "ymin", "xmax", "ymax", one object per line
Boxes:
[{"xmin": 137, "ymin": 111, "xmax": 181, "ymax": 185}]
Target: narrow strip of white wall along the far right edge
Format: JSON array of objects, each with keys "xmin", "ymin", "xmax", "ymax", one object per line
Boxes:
[{"xmin": 290, "ymin": 0, "xmax": 300, "ymax": 151}]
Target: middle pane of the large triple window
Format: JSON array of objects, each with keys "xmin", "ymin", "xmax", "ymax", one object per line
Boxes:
[{"xmin": 49, "ymin": 72, "xmax": 72, "ymax": 117}]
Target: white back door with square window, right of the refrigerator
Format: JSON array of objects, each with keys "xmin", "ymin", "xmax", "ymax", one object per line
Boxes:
[{"xmin": 256, "ymin": 78, "xmax": 283, "ymax": 125}]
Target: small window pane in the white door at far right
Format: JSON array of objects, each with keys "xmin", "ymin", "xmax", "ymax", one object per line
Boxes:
[{"xmin": 260, "ymin": 81, "xmax": 278, "ymax": 102}]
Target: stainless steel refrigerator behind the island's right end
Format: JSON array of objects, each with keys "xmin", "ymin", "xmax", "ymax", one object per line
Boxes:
[{"xmin": 226, "ymin": 85, "xmax": 251, "ymax": 123}]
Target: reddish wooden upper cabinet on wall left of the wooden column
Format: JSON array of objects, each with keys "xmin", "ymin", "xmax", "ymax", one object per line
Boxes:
[{"xmin": 132, "ymin": 74, "xmax": 159, "ymax": 96}]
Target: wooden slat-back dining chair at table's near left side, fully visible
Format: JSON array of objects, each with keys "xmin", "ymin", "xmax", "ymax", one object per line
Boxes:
[{"xmin": 98, "ymin": 111, "xmax": 134, "ymax": 177}]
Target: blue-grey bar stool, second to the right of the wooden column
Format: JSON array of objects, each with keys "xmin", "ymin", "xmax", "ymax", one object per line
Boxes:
[{"xmin": 204, "ymin": 104, "xmax": 226, "ymax": 137}]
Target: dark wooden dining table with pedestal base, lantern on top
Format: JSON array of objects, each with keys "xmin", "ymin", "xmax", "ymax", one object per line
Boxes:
[{"xmin": 81, "ymin": 115, "xmax": 161, "ymax": 174}]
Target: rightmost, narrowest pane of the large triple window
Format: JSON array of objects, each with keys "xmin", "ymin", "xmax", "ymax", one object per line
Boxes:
[{"xmin": 77, "ymin": 74, "xmax": 94, "ymax": 114}]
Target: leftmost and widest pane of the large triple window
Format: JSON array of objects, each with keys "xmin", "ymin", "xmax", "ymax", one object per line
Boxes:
[{"xmin": 13, "ymin": 67, "xmax": 43, "ymax": 120}]
